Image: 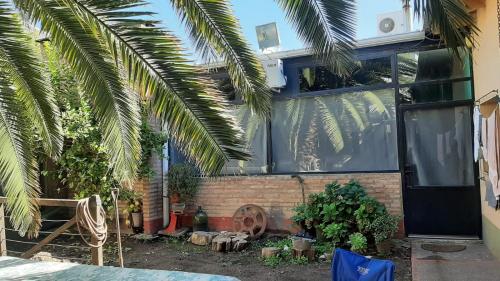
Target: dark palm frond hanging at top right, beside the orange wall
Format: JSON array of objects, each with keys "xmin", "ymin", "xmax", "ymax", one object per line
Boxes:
[{"xmin": 412, "ymin": 0, "xmax": 479, "ymax": 50}]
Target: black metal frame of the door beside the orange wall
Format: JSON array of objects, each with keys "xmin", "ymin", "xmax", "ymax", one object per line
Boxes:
[{"xmin": 398, "ymin": 101, "xmax": 482, "ymax": 235}]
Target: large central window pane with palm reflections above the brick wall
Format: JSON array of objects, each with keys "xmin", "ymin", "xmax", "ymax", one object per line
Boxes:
[{"xmin": 271, "ymin": 89, "xmax": 398, "ymax": 173}]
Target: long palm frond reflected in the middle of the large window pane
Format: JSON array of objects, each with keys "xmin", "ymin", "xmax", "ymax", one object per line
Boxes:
[{"xmin": 314, "ymin": 97, "xmax": 344, "ymax": 152}]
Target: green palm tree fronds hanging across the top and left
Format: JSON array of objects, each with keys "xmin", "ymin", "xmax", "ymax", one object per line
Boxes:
[{"xmin": 0, "ymin": 0, "xmax": 475, "ymax": 234}]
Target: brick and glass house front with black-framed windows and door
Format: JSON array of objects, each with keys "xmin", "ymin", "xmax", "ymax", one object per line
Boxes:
[{"xmin": 135, "ymin": 32, "xmax": 482, "ymax": 238}]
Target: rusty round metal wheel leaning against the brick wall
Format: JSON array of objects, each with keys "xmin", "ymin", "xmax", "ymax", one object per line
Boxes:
[{"xmin": 233, "ymin": 204, "xmax": 267, "ymax": 239}]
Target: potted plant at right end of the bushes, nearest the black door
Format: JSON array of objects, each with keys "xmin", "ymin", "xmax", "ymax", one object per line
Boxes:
[{"xmin": 369, "ymin": 212, "xmax": 399, "ymax": 255}]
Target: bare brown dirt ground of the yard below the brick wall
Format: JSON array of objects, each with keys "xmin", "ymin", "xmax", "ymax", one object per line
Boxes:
[{"xmin": 8, "ymin": 232, "xmax": 411, "ymax": 281}]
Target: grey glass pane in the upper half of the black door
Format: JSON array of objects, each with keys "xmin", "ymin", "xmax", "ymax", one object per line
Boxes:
[{"xmin": 404, "ymin": 106, "xmax": 474, "ymax": 186}]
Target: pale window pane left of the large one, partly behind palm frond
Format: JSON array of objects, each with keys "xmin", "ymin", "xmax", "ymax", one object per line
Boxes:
[{"xmin": 223, "ymin": 105, "xmax": 267, "ymax": 174}]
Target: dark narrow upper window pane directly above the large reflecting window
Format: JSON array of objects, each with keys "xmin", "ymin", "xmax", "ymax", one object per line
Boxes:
[{"xmin": 299, "ymin": 57, "xmax": 392, "ymax": 93}]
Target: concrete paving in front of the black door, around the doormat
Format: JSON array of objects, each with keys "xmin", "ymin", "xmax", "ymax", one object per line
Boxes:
[{"xmin": 411, "ymin": 239, "xmax": 500, "ymax": 281}]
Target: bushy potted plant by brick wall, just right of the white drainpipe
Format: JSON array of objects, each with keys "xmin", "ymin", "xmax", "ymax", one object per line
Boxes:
[{"xmin": 167, "ymin": 164, "xmax": 201, "ymax": 209}]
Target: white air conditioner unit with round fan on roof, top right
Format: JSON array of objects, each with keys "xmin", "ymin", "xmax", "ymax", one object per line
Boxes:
[{"xmin": 377, "ymin": 11, "xmax": 411, "ymax": 36}]
